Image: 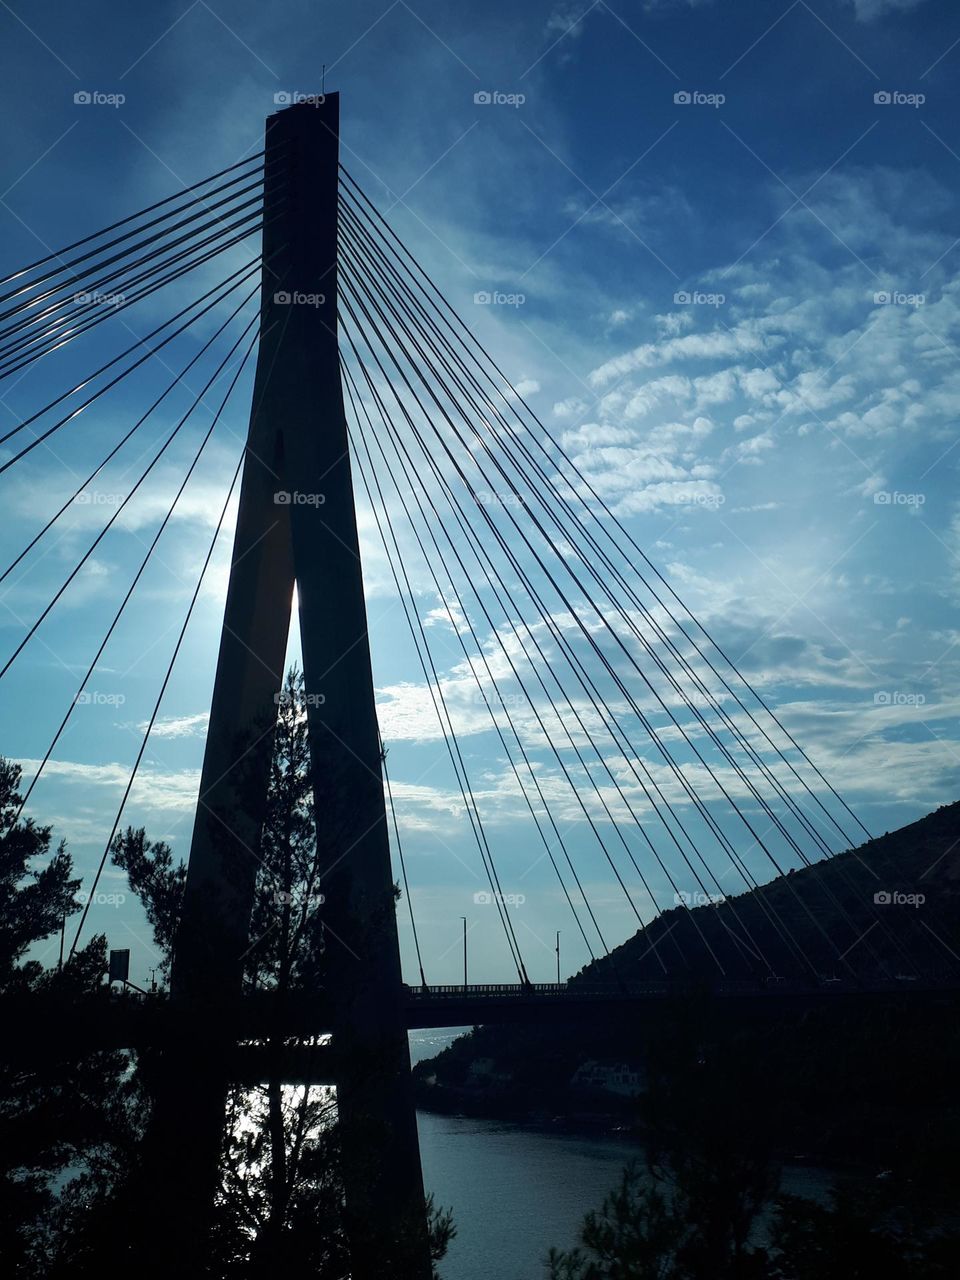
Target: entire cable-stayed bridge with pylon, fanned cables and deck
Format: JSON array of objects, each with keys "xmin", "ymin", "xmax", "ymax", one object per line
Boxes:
[{"xmin": 0, "ymin": 95, "xmax": 956, "ymax": 1280}]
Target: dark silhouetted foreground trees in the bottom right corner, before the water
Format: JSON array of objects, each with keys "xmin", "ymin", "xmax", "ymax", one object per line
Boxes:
[{"xmin": 547, "ymin": 1008, "xmax": 960, "ymax": 1280}]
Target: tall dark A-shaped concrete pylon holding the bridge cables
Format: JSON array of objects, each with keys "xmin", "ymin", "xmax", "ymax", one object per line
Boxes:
[{"xmin": 140, "ymin": 93, "xmax": 430, "ymax": 1280}]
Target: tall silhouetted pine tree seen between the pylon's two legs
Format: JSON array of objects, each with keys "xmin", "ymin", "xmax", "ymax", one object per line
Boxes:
[{"xmin": 113, "ymin": 668, "xmax": 453, "ymax": 1280}]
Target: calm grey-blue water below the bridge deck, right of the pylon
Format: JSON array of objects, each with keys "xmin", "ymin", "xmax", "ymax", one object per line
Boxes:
[{"xmin": 410, "ymin": 1028, "xmax": 831, "ymax": 1280}]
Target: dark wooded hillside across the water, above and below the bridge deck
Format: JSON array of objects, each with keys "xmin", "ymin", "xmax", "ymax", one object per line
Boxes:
[{"xmin": 415, "ymin": 804, "xmax": 960, "ymax": 1167}]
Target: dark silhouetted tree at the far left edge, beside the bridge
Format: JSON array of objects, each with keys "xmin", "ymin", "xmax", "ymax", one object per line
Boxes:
[{"xmin": 0, "ymin": 759, "xmax": 136, "ymax": 1280}]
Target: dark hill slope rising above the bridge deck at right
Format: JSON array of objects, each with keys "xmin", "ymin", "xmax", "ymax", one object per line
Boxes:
[{"xmin": 573, "ymin": 801, "xmax": 960, "ymax": 982}]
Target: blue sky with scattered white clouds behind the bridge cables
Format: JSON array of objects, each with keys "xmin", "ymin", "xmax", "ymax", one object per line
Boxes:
[{"xmin": 0, "ymin": 0, "xmax": 960, "ymax": 980}]
